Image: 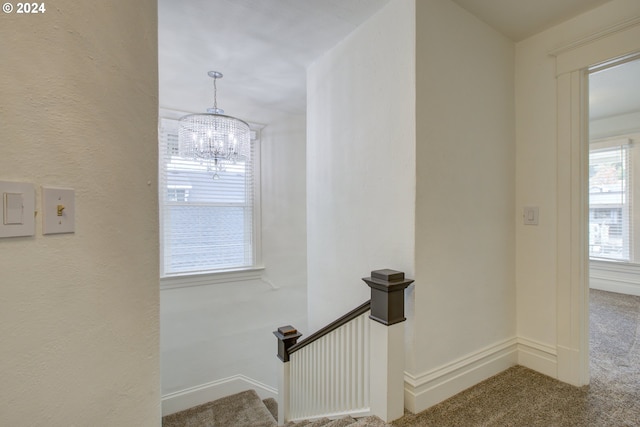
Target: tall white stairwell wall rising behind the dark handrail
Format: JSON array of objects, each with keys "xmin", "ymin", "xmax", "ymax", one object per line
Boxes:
[{"xmin": 307, "ymin": 0, "xmax": 415, "ymax": 330}]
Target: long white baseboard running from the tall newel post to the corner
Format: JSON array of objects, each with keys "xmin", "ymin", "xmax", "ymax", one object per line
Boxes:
[{"xmin": 404, "ymin": 338, "xmax": 518, "ymax": 413}]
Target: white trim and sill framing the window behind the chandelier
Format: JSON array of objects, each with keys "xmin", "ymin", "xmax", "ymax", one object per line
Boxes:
[{"xmin": 158, "ymin": 108, "xmax": 264, "ymax": 289}]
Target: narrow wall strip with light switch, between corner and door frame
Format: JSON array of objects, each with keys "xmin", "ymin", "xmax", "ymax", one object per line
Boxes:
[{"xmin": 516, "ymin": 0, "xmax": 640, "ymax": 376}]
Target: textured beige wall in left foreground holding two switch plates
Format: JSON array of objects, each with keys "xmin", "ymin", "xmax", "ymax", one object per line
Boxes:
[{"xmin": 0, "ymin": 0, "xmax": 160, "ymax": 426}]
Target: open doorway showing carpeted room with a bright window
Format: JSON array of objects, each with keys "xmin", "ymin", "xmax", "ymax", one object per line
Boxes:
[{"xmin": 587, "ymin": 56, "xmax": 640, "ymax": 388}]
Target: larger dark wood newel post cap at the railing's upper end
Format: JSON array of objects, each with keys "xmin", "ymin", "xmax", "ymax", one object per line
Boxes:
[{"xmin": 362, "ymin": 269, "xmax": 413, "ymax": 326}]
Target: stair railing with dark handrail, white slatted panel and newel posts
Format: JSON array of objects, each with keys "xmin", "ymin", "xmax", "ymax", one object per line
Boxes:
[{"xmin": 274, "ymin": 269, "xmax": 413, "ymax": 424}]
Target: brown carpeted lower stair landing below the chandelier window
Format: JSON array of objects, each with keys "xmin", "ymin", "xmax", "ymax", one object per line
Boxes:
[{"xmin": 162, "ymin": 390, "xmax": 278, "ymax": 427}]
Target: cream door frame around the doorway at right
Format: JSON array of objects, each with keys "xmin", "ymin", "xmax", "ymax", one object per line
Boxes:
[{"xmin": 549, "ymin": 17, "xmax": 640, "ymax": 386}]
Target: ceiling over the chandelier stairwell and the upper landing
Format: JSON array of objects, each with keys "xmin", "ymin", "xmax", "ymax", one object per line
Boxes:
[{"xmin": 158, "ymin": 0, "xmax": 636, "ymax": 123}]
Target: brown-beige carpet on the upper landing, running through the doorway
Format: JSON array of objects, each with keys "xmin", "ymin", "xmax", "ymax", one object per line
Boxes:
[{"xmin": 393, "ymin": 290, "xmax": 640, "ymax": 427}]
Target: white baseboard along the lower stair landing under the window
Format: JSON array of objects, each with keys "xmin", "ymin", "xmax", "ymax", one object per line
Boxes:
[{"xmin": 162, "ymin": 375, "xmax": 278, "ymax": 416}]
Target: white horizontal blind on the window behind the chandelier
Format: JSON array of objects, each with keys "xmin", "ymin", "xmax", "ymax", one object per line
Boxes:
[{"xmin": 158, "ymin": 118, "xmax": 256, "ymax": 277}]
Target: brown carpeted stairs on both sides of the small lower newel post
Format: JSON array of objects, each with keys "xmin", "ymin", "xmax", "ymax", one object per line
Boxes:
[{"xmin": 162, "ymin": 390, "xmax": 389, "ymax": 427}]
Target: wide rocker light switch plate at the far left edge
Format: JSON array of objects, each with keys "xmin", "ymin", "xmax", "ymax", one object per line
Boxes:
[{"xmin": 0, "ymin": 181, "xmax": 36, "ymax": 238}]
